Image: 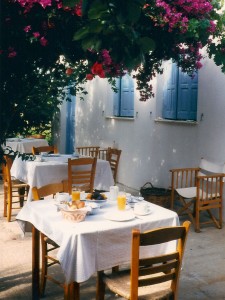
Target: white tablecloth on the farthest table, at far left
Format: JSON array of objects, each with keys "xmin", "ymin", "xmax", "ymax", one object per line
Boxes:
[{"xmin": 4, "ymin": 138, "xmax": 48, "ymax": 153}]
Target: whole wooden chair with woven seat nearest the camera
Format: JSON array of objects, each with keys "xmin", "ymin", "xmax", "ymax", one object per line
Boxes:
[{"xmin": 96, "ymin": 221, "xmax": 190, "ymax": 300}]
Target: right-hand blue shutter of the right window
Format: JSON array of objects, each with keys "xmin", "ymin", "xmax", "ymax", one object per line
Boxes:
[{"xmin": 177, "ymin": 70, "xmax": 198, "ymax": 120}]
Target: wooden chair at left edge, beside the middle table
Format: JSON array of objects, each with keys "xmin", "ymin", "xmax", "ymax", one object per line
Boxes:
[{"xmin": 2, "ymin": 155, "xmax": 29, "ymax": 222}]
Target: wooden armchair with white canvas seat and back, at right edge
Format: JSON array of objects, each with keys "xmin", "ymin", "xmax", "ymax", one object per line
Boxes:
[{"xmin": 170, "ymin": 158, "xmax": 225, "ymax": 232}]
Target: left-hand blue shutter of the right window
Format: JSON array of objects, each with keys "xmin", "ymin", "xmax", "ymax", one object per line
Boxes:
[{"xmin": 162, "ymin": 62, "xmax": 178, "ymax": 119}]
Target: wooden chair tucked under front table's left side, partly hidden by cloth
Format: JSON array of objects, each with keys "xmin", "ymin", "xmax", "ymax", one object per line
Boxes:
[{"xmin": 32, "ymin": 182, "xmax": 79, "ymax": 300}]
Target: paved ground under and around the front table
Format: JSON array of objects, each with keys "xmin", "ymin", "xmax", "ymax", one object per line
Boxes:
[{"xmin": 0, "ymin": 180, "xmax": 225, "ymax": 300}]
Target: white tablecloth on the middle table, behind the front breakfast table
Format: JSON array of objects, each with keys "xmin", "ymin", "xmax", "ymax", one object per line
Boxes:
[{"xmin": 11, "ymin": 154, "xmax": 114, "ymax": 201}]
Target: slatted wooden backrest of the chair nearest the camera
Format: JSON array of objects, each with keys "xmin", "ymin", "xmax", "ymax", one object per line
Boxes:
[{"xmin": 130, "ymin": 221, "xmax": 190, "ymax": 299}]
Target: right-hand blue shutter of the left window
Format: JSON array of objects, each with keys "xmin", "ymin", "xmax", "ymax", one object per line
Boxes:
[{"xmin": 120, "ymin": 75, "xmax": 134, "ymax": 117}]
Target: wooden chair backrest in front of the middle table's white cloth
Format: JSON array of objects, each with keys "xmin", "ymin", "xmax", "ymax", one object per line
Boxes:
[{"xmin": 68, "ymin": 157, "xmax": 97, "ymax": 194}]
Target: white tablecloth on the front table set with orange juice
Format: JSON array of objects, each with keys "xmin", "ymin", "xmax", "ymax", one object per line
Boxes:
[{"xmin": 17, "ymin": 199, "xmax": 179, "ymax": 283}]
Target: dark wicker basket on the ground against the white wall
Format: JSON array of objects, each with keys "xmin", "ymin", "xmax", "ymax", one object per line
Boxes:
[{"xmin": 140, "ymin": 182, "xmax": 171, "ymax": 208}]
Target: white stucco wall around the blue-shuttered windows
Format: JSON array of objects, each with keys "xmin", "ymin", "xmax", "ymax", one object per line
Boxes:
[{"xmin": 72, "ymin": 59, "xmax": 225, "ymax": 189}]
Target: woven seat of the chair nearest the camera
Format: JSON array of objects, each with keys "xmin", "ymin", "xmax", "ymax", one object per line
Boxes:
[{"xmin": 103, "ymin": 270, "xmax": 173, "ymax": 300}]
